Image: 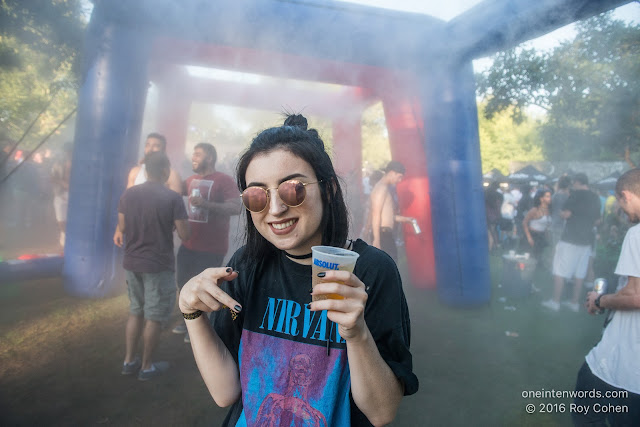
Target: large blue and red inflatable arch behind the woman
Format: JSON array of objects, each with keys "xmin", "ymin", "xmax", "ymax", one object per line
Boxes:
[{"xmin": 55, "ymin": 0, "xmax": 624, "ymax": 306}]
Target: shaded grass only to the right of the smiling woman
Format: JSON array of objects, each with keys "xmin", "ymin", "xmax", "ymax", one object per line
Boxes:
[{"xmin": 394, "ymin": 252, "xmax": 604, "ymax": 426}]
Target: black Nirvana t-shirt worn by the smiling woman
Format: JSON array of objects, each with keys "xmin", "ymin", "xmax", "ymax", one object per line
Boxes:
[{"xmin": 211, "ymin": 240, "xmax": 418, "ymax": 426}]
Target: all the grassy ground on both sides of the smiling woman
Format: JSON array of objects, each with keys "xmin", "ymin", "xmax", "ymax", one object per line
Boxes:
[{"xmin": 0, "ymin": 252, "xmax": 603, "ymax": 426}]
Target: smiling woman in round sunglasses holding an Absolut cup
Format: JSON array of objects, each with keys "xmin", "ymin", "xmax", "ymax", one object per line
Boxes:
[{"xmin": 179, "ymin": 115, "xmax": 418, "ymax": 426}]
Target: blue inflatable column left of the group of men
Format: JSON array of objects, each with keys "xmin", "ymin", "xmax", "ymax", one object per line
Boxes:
[{"xmin": 63, "ymin": 10, "xmax": 149, "ymax": 297}]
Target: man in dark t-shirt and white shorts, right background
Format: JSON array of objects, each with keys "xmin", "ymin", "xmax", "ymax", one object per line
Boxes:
[{"xmin": 542, "ymin": 173, "xmax": 600, "ymax": 312}]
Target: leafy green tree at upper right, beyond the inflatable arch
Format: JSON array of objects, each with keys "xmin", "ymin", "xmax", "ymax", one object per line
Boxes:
[{"xmin": 477, "ymin": 12, "xmax": 640, "ymax": 166}]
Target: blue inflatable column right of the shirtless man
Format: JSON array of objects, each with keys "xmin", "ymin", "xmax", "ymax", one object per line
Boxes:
[{"xmin": 421, "ymin": 63, "xmax": 491, "ymax": 306}]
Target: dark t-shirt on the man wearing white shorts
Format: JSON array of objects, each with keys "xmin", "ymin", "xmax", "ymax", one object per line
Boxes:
[{"xmin": 560, "ymin": 190, "xmax": 600, "ymax": 246}]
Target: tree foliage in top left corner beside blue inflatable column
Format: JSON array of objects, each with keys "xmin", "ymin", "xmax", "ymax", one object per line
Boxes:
[{"xmin": 0, "ymin": 0, "xmax": 86, "ymax": 148}]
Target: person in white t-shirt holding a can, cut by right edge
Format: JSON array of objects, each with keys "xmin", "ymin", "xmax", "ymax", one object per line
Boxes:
[{"xmin": 571, "ymin": 168, "xmax": 640, "ymax": 426}]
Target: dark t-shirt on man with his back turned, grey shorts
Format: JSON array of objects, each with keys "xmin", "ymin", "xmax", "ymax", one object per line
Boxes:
[{"xmin": 118, "ymin": 181, "xmax": 188, "ymax": 273}]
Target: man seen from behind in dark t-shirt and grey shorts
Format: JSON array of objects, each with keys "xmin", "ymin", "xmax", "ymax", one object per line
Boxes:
[{"xmin": 114, "ymin": 152, "xmax": 190, "ymax": 381}]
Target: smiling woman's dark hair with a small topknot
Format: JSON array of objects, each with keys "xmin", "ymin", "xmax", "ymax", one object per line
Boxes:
[{"xmin": 236, "ymin": 114, "xmax": 349, "ymax": 259}]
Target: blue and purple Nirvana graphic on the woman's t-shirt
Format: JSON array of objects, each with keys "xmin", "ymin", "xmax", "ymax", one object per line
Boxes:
[{"xmin": 238, "ymin": 297, "xmax": 350, "ymax": 426}]
